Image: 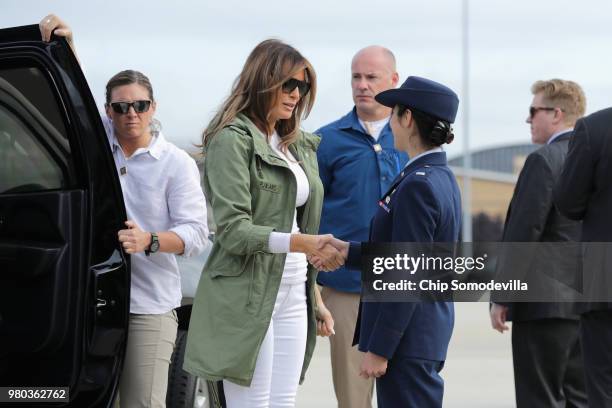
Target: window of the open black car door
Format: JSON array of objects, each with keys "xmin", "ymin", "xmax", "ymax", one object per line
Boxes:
[{"xmin": 0, "ymin": 67, "xmax": 71, "ymax": 194}]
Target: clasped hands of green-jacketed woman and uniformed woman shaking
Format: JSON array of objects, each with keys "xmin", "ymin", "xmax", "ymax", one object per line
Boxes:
[{"xmin": 291, "ymin": 234, "xmax": 349, "ymax": 272}]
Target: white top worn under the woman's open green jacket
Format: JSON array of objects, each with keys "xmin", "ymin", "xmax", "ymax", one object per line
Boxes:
[{"xmin": 268, "ymin": 132, "xmax": 310, "ymax": 285}]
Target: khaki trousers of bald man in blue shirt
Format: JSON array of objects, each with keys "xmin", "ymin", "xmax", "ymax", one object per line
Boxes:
[{"xmin": 321, "ymin": 287, "xmax": 374, "ymax": 408}]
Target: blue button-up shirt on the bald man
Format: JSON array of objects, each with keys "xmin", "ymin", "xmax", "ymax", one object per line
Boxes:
[{"xmin": 315, "ymin": 108, "xmax": 408, "ymax": 293}]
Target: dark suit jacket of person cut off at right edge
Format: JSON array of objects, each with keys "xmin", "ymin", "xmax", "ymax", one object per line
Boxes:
[{"xmin": 554, "ymin": 108, "xmax": 612, "ymax": 312}]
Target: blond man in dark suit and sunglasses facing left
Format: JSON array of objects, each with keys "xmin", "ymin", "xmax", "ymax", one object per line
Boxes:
[{"xmin": 490, "ymin": 79, "xmax": 587, "ymax": 408}]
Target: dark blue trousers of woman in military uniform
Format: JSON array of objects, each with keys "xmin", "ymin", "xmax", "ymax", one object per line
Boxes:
[{"xmin": 376, "ymin": 357, "xmax": 444, "ymax": 408}]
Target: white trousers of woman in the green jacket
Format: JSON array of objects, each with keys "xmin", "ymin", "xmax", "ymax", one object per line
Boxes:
[{"xmin": 223, "ymin": 283, "xmax": 308, "ymax": 408}]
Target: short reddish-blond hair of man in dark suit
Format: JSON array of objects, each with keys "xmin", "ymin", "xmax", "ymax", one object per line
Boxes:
[{"xmin": 531, "ymin": 78, "xmax": 586, "ymax": 125}]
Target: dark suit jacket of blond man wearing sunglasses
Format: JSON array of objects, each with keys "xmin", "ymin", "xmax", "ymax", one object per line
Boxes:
[{"xmin": 498, "ymin": 131, "xmax": 581, "ymax": 321}]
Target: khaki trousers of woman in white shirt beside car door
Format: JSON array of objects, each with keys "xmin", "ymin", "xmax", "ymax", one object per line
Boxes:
[{"xmin": 115, "ymin": 310, "xmax": 178, "ymax": 408}]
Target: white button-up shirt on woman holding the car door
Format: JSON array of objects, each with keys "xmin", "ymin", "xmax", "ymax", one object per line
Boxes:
[{"xmin": 103, "ymin": 117, "xmax": 209, "ymax": 314}]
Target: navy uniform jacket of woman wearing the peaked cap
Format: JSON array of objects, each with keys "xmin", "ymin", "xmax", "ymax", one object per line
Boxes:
[{"xmin": 347, "ymin": 152, "xmax": 461, "ymax": 361}]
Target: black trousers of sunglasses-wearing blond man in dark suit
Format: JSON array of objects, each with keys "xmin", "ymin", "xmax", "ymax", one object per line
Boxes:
[{"xmin": 512, "ymin": 319, "xmax": 595, "ymax": 408}]
